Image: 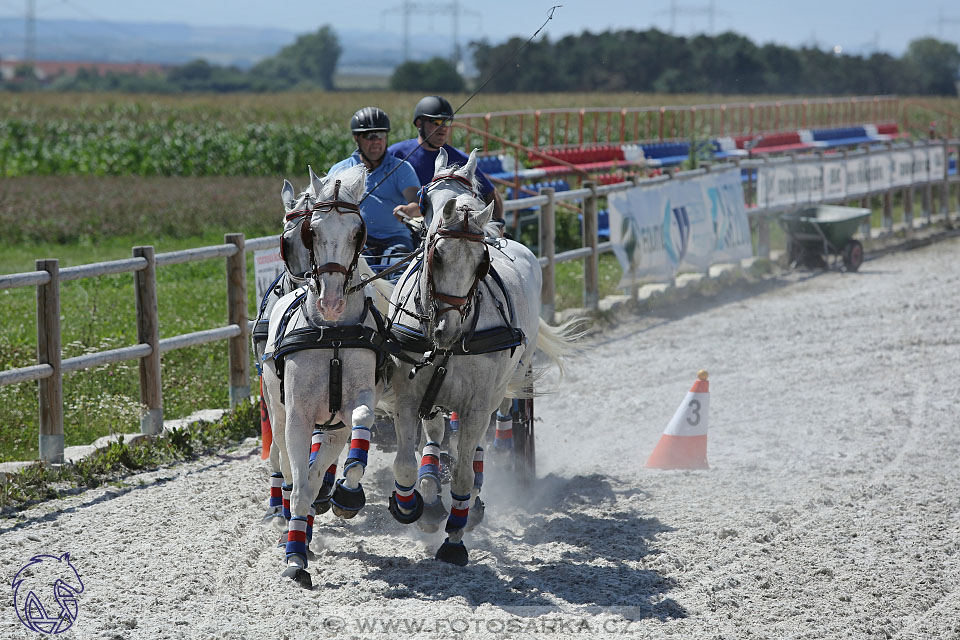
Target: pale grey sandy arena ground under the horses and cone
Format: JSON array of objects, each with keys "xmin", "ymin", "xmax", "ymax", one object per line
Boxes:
[{"xmin": 0, "ymin": 238, "xmax": 960, "ymax": 639}]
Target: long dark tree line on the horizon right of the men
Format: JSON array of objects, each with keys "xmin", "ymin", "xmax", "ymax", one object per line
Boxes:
[{"xmin": 471, "ymin": 29, "xmax": 960, "ymax": 95}]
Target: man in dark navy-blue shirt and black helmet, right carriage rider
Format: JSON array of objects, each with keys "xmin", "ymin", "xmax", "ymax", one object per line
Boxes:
[{"xmin": 387, "ymin": 96, "xmax": 503, "ymax": 222}]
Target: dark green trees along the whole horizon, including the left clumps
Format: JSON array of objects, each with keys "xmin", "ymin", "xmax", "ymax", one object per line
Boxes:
[{"xmin": 0, "ymin": 26, "xmax": 960, "ymax": 95}]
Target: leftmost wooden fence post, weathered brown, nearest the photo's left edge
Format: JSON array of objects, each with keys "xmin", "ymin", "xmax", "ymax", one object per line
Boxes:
[{"xmin": 36, "ymin": 259, "xmax": 63, "ymax": 464}]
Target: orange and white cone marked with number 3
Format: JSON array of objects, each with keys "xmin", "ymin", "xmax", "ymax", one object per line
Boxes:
[{"xmin": 647, "ymin": 370, "xmax": 710, "ymax": 469}]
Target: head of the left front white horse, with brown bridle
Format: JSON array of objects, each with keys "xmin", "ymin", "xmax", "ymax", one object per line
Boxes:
[{"xmin": 281, "ymin": 165, "xmax": 367, "ymax": 321}]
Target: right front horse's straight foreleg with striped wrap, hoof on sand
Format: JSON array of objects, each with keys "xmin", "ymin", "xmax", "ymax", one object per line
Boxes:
[{"xmin": 437, "ymin": 410, "xmax": 490, "ymax": 566}]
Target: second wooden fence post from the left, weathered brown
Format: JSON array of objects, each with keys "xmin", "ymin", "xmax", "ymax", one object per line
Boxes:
[{"xmin": 133, "ymin": 247, "xmax": 163, "ymax": 435}]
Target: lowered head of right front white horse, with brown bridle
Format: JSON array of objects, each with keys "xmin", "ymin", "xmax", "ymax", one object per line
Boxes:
[{"xmin": 421, "ymin": 194, "xmax": 493, "ymax": 350}]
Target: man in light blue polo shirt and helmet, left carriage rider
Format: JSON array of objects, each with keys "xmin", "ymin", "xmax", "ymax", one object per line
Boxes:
[{"xmin": 327, "ymin": 107, "xmax": 421, "ymax": 254}]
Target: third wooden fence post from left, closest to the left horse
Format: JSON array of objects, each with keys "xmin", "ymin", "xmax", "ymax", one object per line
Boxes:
[{"xmin": 223, "ymin": 233, "xmax": 250, "ymax": 409}]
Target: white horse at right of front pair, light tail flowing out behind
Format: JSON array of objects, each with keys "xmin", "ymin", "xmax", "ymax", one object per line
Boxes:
[{"xmin": 391, "ymin": 152, "xmax": 570, "ymax": 566}]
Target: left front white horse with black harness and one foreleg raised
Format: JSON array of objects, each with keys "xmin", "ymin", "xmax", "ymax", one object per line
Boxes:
[{"xmin": 262, "ymin": 166, "xmax": 385, "ymax": 588}]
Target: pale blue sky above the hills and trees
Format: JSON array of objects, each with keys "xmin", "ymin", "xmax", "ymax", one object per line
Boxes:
[{"xmin": 0, "ymin": 0, "xmax": 960, "ymax": 55}]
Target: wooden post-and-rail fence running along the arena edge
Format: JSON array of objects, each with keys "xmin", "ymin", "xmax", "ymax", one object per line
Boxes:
[{"xmin": 0, "ymin": 141, "xmax": 960, "ymax": 463}]
